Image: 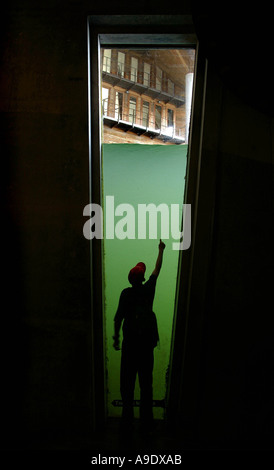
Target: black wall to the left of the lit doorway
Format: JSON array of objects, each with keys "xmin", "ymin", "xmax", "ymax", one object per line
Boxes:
[{"xmin": 1, "ymin": 2, "xmax": 92, "ymax": 446}]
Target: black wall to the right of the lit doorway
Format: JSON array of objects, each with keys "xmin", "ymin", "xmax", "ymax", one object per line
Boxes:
[{"xmin": 186, "ymin": 7, "xmax": 274, "ymax": 448}]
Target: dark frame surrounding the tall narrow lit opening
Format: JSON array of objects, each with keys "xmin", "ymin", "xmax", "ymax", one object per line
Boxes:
[{"xmin": 88, "ymin": 15, "xmax": 219, "ymax": 429}]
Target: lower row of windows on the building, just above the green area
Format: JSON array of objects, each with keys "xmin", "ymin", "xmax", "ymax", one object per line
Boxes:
[{"xmin": 102, "ymin": 88, "xmax": 174, "ymax": 133}]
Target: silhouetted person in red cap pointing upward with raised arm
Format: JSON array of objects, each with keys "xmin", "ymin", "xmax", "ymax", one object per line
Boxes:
[{"xmin": 113, "ymin": 240, "xmax": 165, "ymax": 429}]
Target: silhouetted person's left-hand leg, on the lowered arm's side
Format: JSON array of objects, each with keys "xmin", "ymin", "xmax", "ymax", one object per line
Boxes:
[{"xmin": 120, "ymin": 348, "xmax": 137, "ymax": 426}]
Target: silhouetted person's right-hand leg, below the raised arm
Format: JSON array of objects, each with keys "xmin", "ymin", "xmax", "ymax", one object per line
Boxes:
[{"xmin": 138, "ymin": 348, "xmax": 154, "ymax": 427}]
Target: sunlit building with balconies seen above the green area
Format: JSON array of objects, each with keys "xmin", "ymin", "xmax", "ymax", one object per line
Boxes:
[{"xmin": 101, "ymin": 49, "xmax": 195, "ymax": 144}]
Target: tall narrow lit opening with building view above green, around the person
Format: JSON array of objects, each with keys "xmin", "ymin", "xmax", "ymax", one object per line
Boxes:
[{"xmin": 99, "ymin": 44, "xmax": 195, "ymax": 419}]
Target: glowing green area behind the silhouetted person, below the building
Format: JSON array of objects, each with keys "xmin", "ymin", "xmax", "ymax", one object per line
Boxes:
[{"xmin": 102, "ymin": 144, "xmax": 187, "ymax": 418}]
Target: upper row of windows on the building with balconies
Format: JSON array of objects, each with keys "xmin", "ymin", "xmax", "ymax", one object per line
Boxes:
[{"xmin": 103, "ymin": 49, "xmax": 174, "ymax": 95}]
